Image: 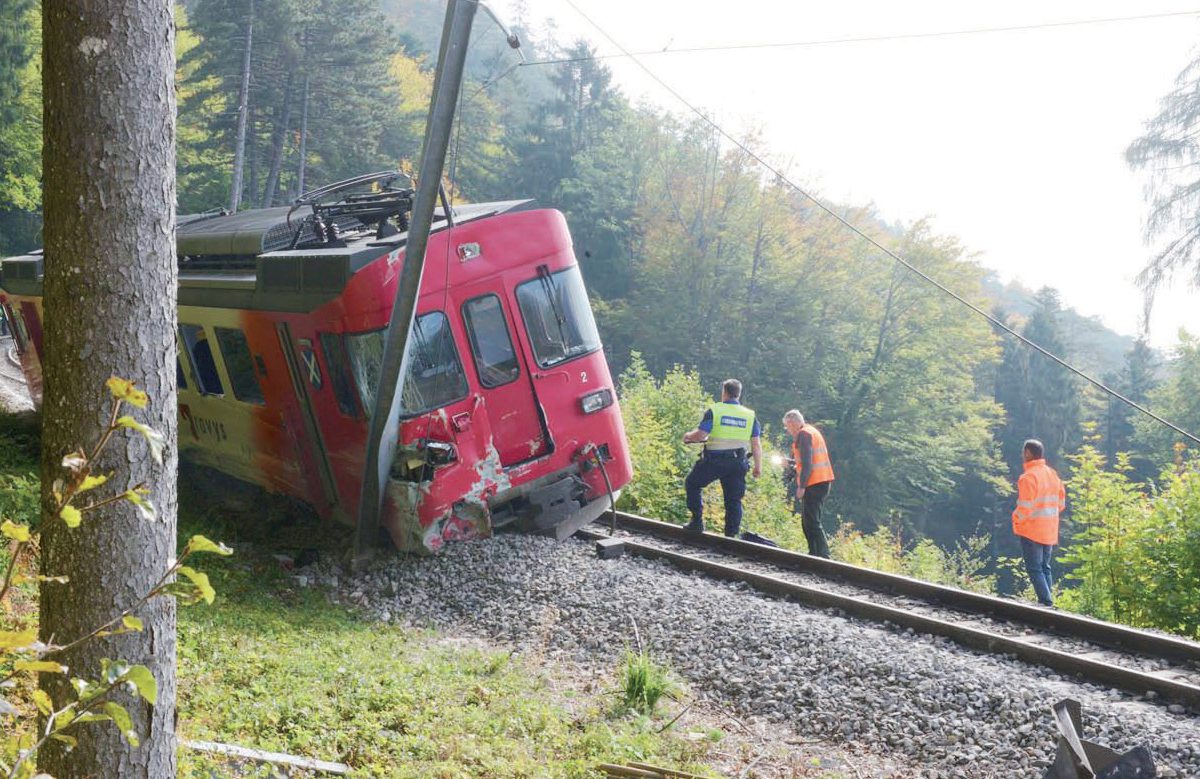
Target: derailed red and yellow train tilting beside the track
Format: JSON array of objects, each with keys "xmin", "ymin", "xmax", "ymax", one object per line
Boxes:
[{"xmin": 0, "ymin": 174, "xmax": 632, "ymax": 551}]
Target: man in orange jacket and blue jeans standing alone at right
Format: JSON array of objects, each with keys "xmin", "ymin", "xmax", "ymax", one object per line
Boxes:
[{"xmin": 1013, "ymin": 438, "xmax": 1067, "ymax": 606}]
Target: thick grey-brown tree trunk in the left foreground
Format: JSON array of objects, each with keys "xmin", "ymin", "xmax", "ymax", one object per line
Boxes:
[{"xmin": 38, "ymin": 0, "xmax": 178, "ymax": 779}]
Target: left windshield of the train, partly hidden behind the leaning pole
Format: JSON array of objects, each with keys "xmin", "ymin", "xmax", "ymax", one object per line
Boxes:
[{"xmin": 346, "ymin": 311, "xmax": 467, "ymax": 417}]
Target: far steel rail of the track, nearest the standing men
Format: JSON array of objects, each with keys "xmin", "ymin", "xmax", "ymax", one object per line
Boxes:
[{"xmin": 617, "ymin": 511, "xmax": 1200, "ymax": 663}]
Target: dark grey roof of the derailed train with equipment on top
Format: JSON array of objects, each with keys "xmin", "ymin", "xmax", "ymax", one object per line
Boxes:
[{"xmin": 0, "ymin": 199, "xmax": 533, "ymax": 312}]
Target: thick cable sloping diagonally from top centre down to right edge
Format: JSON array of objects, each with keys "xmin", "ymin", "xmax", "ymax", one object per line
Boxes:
[{"xmin": 566, "ymin": 0, "xmax": 1200, "ymax": 444}]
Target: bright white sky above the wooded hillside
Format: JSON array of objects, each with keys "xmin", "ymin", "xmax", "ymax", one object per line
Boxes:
[{"xmin": 493, "ymin": 0, "xmax": 1200, "ymax": 347}]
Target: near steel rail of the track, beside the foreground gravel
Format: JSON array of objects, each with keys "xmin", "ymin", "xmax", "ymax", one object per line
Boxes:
[{"xmin": 580, "ymin": 525, "xmax": 1200, "ymax": 711}]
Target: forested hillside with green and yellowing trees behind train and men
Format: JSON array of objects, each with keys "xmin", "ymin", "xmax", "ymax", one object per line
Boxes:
[{"xmin": 0, "ymin": 0, "xmax": 1200, "ymax": 633}]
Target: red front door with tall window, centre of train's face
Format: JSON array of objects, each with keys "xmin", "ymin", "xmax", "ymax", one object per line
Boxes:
[{"xmin": 462, "ymin": 292, "xmax": 550, "ymax": 466}]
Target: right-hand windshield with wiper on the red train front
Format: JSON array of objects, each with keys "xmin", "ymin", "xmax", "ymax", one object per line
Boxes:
[{"xmin": 517, "ymin": 266, "xmax": 600, "ymax": 367}]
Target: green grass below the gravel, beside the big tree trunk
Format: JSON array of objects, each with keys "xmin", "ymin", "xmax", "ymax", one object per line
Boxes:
[{"xmin": 0, "ymin": 410, "xmax": 713, "ymax": 779}]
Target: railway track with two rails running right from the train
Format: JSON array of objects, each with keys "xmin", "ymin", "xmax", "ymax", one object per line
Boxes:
[{"xmin": 581, "ymin": 513, "xmax": 1200, "ymax": 712}]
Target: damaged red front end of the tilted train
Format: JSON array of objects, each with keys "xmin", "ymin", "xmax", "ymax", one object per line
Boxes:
[{"xmin": 347, "ymin": 210, "xmax": 632, "ymax": 552}]
